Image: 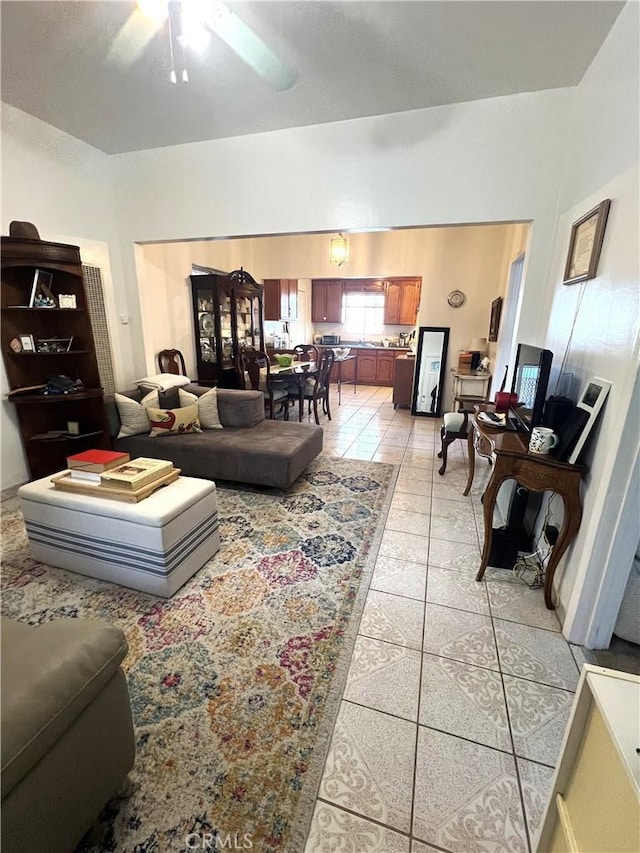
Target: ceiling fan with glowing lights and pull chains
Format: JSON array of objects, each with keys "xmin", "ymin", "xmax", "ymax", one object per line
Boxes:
[{"xmin": 109, "ymin": 0, "xmax": 298, "ymax": 91}]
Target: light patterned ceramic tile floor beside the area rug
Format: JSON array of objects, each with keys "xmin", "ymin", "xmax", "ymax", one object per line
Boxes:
[{"xmin": 306, "ymin": 386, "xmax": 581, "ymax": 853}]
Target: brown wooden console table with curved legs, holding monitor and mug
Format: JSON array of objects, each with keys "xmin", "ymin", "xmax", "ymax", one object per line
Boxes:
[{"xmin": 464, "ymin": 406, "xmax": 586, "ymax": 610}]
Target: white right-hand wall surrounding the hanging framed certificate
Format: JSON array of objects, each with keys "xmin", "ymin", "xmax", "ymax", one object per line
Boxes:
[{"xmin": 546, "ymin": 3, "xmax": 640, "ymax": 648}]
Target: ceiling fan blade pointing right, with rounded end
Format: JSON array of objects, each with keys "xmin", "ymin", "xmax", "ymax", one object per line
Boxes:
[{"xmin": 206, "ymin": 2, "xmax": 298, "ymax": 91}]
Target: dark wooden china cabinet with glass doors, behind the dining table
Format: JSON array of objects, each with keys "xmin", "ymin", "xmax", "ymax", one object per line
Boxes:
[{"xmin": 190, "ymin": 269, "xmax": 264, "ymax": 388}]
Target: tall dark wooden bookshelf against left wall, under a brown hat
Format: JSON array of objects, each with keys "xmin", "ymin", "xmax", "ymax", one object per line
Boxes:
[{"xmin": 0, "ymin": 237, "xmax": 111, "ymax": 479}]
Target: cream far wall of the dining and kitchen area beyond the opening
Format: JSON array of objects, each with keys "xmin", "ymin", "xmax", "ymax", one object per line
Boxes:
[{"xmin": 139, "ymin": 225, "xmax": 528, "ymax": 405}]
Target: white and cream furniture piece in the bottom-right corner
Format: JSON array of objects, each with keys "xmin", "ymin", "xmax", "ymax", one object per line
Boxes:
[{"xmin": 535, "ymin": 665, "xmax": 640, "ymax": 853}]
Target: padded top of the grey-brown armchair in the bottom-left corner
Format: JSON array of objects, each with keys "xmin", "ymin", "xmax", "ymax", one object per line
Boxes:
[{"xmin": 2, "ymin": 618, "xmax": 127, "ymax": 800}]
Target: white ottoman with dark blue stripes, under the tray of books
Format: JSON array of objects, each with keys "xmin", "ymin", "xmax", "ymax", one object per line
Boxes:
[{"xmin": 18, "ymin": 477, "xmax": 220, "ymax": 598}]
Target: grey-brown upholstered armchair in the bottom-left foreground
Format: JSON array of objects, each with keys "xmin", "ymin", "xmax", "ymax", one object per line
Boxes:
[{"xmin": 2, "ymin": 618, "xmax": 135, "ymax": 853}]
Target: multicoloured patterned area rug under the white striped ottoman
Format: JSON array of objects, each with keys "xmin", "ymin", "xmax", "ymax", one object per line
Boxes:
[{"xmin": 2, "ymin": 456, "xmax": 397, "ymax": 853}]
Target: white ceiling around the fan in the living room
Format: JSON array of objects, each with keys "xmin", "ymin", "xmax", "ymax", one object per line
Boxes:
[{"xmin": 0, "ymin": 0, "xmax": 624, "ymax": 153}]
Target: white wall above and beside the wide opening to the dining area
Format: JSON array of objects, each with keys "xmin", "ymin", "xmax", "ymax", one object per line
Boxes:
[{"xmin": 113, "ymin": 83, "xmax": 572, "ymax": 368}]
